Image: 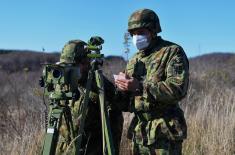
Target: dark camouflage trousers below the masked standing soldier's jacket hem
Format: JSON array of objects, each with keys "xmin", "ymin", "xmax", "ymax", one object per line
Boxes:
[{"xmin": 132, "ymin": 139, "xmax": 182, "ymax": 155}]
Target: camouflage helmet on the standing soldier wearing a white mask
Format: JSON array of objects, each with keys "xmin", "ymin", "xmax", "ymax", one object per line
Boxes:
[{"xmin": 128, "ymin": 9, "xmax": 162, "ymax": 33}]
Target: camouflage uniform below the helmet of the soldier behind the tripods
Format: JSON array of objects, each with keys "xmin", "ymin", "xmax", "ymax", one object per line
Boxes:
[{"xmin": 56, "ymin": 77, "xmax": 123, "ymax": 155}]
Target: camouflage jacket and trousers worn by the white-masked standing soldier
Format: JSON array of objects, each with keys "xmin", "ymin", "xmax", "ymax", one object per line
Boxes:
[{"xmin": 126, "ymin": 37, "xmax": 189, "ymax": 154}]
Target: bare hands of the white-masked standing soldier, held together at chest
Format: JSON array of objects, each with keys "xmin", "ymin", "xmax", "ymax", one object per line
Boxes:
[{"xmin": 115, "ymin": 72, "xmax": 140, "ymax": 92}]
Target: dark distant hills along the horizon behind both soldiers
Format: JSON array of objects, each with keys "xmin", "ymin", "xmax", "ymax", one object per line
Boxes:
[{"xmin": 0, "ymin": 49, "xmax": 235, "ymax": 73}]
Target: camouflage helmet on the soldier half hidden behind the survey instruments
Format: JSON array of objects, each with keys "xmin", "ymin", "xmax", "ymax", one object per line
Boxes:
[{"xmin": 60, "ymin": 40, "xmax": 87, "ymax": 63}]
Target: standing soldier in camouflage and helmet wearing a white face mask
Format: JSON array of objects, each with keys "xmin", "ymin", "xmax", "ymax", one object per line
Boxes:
[{"xmin": 115, "ymin": 9, "xmax": 189, "ymax": 155}]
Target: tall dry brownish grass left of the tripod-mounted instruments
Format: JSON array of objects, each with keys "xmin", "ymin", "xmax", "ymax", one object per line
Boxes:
[{"xmin": 0, "ymin": 72, "xmax": 45, "ymax": 155}]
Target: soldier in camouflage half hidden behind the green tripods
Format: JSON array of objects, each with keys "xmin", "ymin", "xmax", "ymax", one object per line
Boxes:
[{"xmin": 56, "ymin": 40, "xmax": 123, "ymax": 155}]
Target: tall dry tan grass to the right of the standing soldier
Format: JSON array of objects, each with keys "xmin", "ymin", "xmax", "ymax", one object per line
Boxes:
[{"xmin": 183, "ymin": 83, "xmax": 235, "ymax": 155}]
